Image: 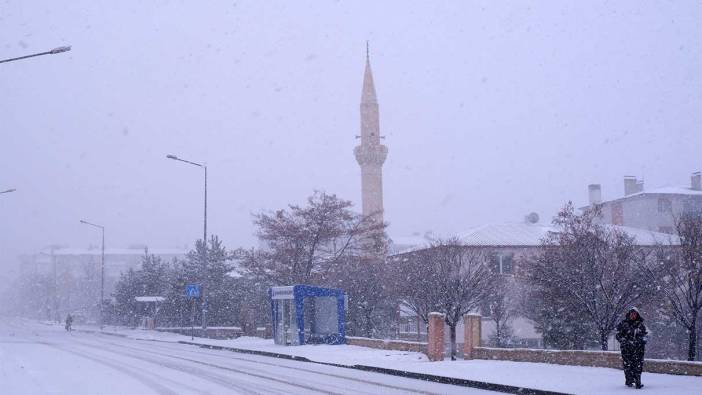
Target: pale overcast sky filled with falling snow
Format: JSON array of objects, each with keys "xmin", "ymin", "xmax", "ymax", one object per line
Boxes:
[{"xmin": 0, "ymin": 0, "xmax": 702, "ymax": 276}]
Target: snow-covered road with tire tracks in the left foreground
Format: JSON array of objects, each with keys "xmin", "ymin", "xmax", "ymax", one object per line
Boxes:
[{"xmin": 0, "ymin": 321, "xmax": 496, "ymax": 394}]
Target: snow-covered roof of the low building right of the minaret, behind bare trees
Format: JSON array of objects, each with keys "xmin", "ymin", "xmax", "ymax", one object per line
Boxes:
[{"xmin": 392, "ymin": 222, "xmax": 678, "ymax": 255}]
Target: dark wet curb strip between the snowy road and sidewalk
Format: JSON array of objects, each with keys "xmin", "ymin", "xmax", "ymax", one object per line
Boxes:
[{"xmin": 178, "ymin": 340, "xmax": 568, "ymax": 395}]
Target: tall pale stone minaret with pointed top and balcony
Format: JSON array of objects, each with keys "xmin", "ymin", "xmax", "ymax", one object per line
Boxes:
[{"xmin": 353, "ymin": 42, "xmax": 388, "ymax": 223}]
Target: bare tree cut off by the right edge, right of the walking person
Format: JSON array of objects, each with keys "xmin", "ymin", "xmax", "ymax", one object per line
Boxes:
[{"xmin": 644, "ymin": 213, "xmax": 702, "ymax": 361}]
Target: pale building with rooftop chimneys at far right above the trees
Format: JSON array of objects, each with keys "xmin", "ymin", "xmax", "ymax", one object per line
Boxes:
[{"xmin": 583, "ymin": 172, "xmax": 702, "ymax": 234}]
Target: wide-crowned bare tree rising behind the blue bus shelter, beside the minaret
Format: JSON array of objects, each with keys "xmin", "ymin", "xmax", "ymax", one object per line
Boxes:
[{"xmin": 235, "ymin": 192, "xmax": 385, "ymax": 284}]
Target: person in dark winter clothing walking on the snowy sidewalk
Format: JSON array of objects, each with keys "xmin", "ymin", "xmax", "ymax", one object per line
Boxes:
[{"xmin": 616, "ymin": 307, "xmax": 648, "ymax": 388}]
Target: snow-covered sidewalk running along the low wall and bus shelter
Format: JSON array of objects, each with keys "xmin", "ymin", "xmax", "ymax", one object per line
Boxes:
[{"xmin": 79, "ymin": 327, "xmax": 702, "ymax": 395}]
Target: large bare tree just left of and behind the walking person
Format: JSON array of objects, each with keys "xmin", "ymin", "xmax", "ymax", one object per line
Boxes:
[{"xmin": 527, "ymin": 202, "xmax": 650, "ymax": 350}]
